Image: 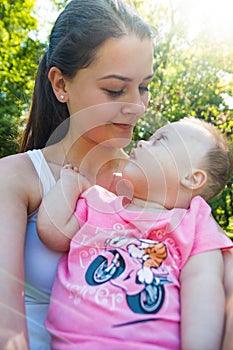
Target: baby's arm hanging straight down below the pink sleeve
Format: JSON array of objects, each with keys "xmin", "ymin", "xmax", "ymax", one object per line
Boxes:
[{"xmin": 180, "ymin": 250, "xmax": 225, "ymax": 350}]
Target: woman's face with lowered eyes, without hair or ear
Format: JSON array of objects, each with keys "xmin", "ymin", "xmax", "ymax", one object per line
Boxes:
[{"xmin": 65, "ymin": 35, "xmax": 153, "ymax": 147}]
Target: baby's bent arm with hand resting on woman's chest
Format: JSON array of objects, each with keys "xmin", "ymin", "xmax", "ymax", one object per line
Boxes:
[{"xmin": 37, "ymin": 165, "xmax": 90, "ymax": 251}]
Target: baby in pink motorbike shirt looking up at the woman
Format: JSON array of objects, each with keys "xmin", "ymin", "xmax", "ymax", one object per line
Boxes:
[{"xmin": 37, "ymin": 118, "xmax": 232, "ymax": 350}]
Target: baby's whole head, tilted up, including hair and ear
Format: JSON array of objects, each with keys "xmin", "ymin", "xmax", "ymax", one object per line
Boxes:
[{"xmin": 123, "ymin": 118, "xmax": 233, "ymax": 209}]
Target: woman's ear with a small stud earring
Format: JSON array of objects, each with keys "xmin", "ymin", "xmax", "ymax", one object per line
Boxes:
[{"xmin": 48, "ymin": 67, "xmax": 68, "ymax": 103}]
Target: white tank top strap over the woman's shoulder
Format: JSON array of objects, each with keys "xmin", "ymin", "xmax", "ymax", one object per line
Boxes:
[{"xmin": 27, "ymin": 149, "xmax": 56, "ymax": 196}]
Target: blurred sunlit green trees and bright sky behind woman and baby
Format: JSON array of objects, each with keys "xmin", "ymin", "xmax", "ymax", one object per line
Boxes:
[{"xmin": 0, "ymin": 0, "xmax": 233, "ymax": 238}]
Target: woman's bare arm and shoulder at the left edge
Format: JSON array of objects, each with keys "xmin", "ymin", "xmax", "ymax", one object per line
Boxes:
[{"xmin": 0, "ymin": 155, "xmax": 39, "ymax": 349}]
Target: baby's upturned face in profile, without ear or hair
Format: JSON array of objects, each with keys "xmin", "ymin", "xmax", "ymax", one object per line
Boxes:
[{"xmin": 123, "ymin": 122, "xmax": 213, "ymax": 206}]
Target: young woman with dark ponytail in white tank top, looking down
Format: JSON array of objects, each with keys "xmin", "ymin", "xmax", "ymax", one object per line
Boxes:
[{"xmin": 0, "ymin": 0, "xmax": 153, "ymax": 350}]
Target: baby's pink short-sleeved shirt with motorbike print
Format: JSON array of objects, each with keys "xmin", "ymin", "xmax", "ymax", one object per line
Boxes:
[{"xmin": 46, "ymin": 186, "xmax": 232, "ymax": 350}]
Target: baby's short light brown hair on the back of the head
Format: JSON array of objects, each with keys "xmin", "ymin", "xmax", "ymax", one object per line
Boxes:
[{"xmin": 180, "ymin": 117, "xmax": 233, "ymax": 201}]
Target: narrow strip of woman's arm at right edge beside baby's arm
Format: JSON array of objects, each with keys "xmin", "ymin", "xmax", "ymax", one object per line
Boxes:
[{"xmin": 222, "ymin": 249, "xmax": 233, "ymax": 350}]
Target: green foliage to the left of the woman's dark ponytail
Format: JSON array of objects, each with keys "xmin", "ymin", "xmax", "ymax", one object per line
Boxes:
[{"xmin": 0, "ymin": 0, "xmax": 43, "ymax": 157}]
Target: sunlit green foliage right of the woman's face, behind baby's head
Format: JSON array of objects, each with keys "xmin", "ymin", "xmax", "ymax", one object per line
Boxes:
[{"xmin": 129, "ymin": 0, "xmax": 233, "ymax": 235}]
